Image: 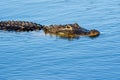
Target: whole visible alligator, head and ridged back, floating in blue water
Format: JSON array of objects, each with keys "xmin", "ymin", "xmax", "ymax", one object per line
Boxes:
[{"xmin": 0, "ymin": 21, "xmax": 100, "ymax": 38}]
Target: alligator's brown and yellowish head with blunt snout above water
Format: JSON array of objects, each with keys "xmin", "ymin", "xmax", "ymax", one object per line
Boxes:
[{"xmin": 43, "ymin": 23, "xmax": 100, "ymax": 38}]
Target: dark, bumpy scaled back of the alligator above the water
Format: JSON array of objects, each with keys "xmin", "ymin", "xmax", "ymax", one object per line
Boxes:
[{"xmin": 0, "ymin": 21, "xmax": 43, "ymax": 31}]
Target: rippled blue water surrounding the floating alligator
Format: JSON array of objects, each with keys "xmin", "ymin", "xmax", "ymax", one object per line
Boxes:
[{"xmin": 0, "ymin": 0, "xmax": 120, "ymax": 80}]
